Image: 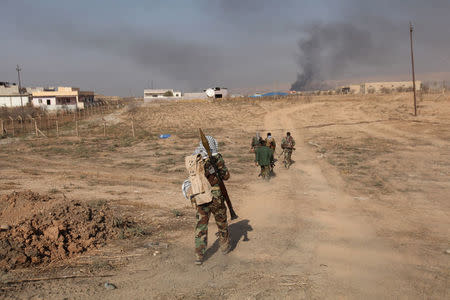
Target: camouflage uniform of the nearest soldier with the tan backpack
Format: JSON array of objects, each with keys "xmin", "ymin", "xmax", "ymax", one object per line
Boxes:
[{"xmin": 195, "ymin": 154, "xmax": 230, "ymax": 261}]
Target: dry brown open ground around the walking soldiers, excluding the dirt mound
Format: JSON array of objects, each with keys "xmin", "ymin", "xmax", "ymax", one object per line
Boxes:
[{"xmin": 0, "ymin": 94, "xmax": 450, "ymax": 299}]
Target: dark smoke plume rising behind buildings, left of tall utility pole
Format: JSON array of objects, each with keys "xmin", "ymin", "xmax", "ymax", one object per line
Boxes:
[{"xmin": 291, "ymin": 23, "xmax": 374, "ymax": 91}]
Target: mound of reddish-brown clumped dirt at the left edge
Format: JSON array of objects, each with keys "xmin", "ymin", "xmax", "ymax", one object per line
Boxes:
[{"xmin": 0, "ymin": 191, "xmax": 140, "ymax": 270}]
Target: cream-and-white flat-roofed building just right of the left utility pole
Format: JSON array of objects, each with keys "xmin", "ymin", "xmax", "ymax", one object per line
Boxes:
[{"xmin": 30, "ymin": 87, "xmax": 94, "ymax": 110}]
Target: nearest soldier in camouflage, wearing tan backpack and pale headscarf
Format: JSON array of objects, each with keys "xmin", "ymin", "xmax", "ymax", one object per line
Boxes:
[{"xmin": 182, "ymin": 136, "xmax": 231, "ymax": 265}]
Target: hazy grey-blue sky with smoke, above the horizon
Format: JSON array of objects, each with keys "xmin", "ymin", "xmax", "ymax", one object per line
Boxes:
[{"xmin": 0, "ymin": 0, "xmax": 450, "ymax": 96}]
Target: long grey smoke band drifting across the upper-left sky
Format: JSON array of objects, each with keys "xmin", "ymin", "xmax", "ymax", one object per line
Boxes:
[{"xmin": 0, "ymin": 1, "xmax": 226, "ymax": 88}]
